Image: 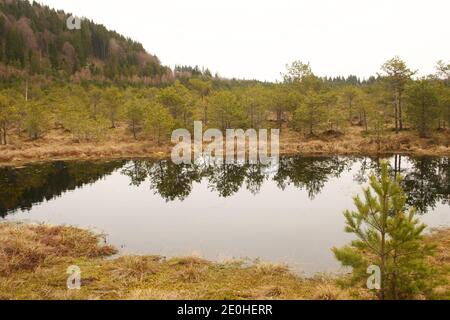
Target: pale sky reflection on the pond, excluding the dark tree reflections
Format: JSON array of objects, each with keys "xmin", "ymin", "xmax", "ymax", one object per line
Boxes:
[{"xmin": 3, "ymin": 160, "xmax": 450, "ymax": 273}]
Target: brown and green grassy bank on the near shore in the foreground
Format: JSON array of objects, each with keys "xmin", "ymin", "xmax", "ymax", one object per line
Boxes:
[{"xmin": 0, "ymin": 223, "xmax": 450, "ymax": 299}]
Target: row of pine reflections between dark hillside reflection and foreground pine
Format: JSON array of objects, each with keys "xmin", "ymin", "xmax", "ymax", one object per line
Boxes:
[{"xmin": 122, "ymin": 157, "xmax": 354, "ymax": 201}]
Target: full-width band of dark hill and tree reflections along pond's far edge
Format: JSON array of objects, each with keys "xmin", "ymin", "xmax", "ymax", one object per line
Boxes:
[{"xmin": 0, "ymin": 156, "xmax": 450, "ymax": 216}]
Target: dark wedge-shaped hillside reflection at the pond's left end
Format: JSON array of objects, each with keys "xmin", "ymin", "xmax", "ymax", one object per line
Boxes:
[{"xmin": 0, "ymin": 161, "xmax": 123, "ymax": 217}]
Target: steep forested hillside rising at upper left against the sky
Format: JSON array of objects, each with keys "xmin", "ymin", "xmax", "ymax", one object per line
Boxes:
[{"xmin": 0, "ymin": 0, "xmax": 172, "ymax": 83}]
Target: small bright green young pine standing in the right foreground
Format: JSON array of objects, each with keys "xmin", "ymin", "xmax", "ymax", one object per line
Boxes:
[{"xmin": 333, "ymin": 161, "xmax": 438, "ymax": 300}]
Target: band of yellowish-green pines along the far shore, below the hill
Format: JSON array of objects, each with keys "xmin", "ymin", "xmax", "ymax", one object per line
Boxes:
[{"xmin": 0, "ymin": 57, "xmax": 450, "ymax": 144}]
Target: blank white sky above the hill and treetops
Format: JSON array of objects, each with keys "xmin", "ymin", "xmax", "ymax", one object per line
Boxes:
[{"xmin": 33, "ymin": 0, "xmax": 450, "ymax": 81}]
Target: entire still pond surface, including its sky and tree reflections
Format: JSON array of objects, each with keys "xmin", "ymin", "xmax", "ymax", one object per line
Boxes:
[{"xmin": 0, "ymin": 156, "xmax": 450, "ymax": 274}]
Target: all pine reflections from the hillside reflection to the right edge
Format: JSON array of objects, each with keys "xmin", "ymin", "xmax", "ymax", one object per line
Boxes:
[{"xmin": 123, "ymin": 155, "xmax": 450, "ymax": 212}]
